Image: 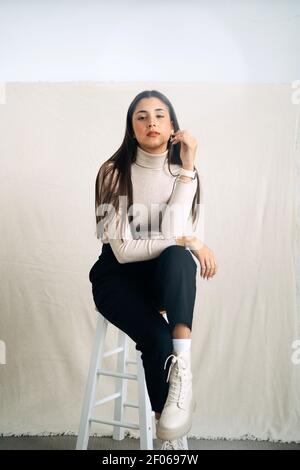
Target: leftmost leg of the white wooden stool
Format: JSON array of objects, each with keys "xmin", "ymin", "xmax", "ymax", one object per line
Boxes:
[{"xmin": 76, "ymin": 314, "xmax": 108, "ymax": 450}]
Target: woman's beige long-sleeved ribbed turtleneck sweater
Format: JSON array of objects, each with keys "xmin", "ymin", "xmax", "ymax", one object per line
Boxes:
[{"xmin": 100, "ymin": 146, "xmax": 197, "ymax": 263}]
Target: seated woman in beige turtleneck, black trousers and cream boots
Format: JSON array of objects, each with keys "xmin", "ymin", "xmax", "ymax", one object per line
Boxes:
[{"xmin": 89, "ymin": 90, "xmax": 217, "ymax": 449}]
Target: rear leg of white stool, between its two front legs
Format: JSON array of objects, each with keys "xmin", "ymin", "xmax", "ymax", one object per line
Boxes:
[{"xmin": 113, "ymin": 330, "xmax": 128, "ymax": 441}]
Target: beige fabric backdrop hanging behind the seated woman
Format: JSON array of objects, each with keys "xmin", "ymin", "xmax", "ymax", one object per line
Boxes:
[{"xmin": 0, "ymin": 82, "xmax": 300, "ymax": 442}]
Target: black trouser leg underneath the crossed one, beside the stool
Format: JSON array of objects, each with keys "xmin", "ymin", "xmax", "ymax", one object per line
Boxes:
[{"xmin": 90, "ymin": 248, "xmax": 173, "ymax": 413}]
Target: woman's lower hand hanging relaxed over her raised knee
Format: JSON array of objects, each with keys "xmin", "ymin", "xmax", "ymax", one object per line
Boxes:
[{"xmin": 178, "ymin": 236, "xmax": 218, "ymax": 280}]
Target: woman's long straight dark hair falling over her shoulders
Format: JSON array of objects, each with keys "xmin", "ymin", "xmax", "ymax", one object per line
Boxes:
[{"xmin": 95, "ymin": 90, "xmax": 200, "ymax": 238}]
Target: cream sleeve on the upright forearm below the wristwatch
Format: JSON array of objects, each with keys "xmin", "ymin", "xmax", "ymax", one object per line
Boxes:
[{"xmin": 161, "ymin": 178, "xmax": 197, "ymax": 238}]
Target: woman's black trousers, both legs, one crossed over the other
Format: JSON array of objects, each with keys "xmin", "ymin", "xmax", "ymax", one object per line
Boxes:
[{"xmin": 89, "ymin": 244, "xmax": 197, "ymax": 413}]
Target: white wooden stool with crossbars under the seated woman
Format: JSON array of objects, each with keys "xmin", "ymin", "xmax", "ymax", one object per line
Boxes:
[{"xmin": 76, "ymin": 307, "xmax": 155, "ymax": 450}]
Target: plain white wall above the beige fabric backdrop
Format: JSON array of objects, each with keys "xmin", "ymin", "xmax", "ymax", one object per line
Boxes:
[{"xmin": 0, "ymin": 0, "xmax": 300, "ymax": 83}]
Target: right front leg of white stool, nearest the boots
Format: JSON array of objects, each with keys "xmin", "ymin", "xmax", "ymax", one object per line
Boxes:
[{"xmin": 136, "ymin": 350, "xmax": 153, "ymax": 450}]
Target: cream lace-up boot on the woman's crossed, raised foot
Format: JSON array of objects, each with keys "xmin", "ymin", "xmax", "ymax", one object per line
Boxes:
[{"xmin": 156, "ymin": 348, "xmax": 196, "ymax": 445}]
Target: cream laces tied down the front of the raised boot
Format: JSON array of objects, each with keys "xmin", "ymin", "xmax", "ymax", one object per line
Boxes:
[{"xmin": 164, "ymin": 354, "xmax": 187, "ymax": 403}]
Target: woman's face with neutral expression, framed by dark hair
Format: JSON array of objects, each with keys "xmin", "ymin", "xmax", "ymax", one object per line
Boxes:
[{"xmin": 132, "ymin": 97, "xmax": 174, "ymax": 153}]
